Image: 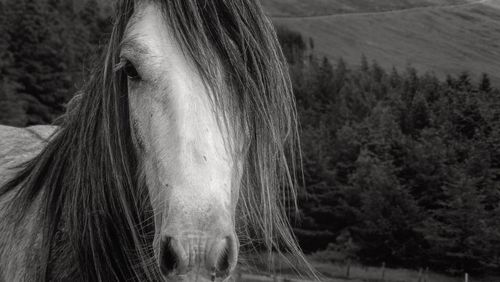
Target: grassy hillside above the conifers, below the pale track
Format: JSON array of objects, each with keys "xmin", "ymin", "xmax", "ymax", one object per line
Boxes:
[{"xmin": 266, "ymin": 0, "xmax": 500, "ymax": 86}]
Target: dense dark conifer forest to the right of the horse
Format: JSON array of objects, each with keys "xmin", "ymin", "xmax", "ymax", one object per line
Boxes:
[{"xmin": 279, "ymin": 28, "xmax": 500, "ymax": 273}]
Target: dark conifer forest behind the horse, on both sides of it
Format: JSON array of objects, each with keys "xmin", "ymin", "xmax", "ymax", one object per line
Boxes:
[{"xmin": 0, "ymin": 0, "xmax": 500, "ymax": 278}]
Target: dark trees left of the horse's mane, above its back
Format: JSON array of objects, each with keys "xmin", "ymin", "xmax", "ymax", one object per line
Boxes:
[{"xmin": 0, "ymin": 0, "xmax": 111, "ymax": 126}]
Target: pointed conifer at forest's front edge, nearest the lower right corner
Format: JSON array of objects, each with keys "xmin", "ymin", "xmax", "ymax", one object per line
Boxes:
[{"xmin": 423, "ymin": 173, "xmax": 488, "ymax": 272}]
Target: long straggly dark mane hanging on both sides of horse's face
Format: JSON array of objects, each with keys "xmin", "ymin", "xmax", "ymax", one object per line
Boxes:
[{"xmin": 0, "ymin": 0, "xmax": 307, "ymax": 281}]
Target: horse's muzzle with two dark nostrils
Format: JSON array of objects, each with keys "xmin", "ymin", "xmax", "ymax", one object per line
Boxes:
[{"xmin": 159, "ymin": 232, "xmax": 238, "ymax": 281}]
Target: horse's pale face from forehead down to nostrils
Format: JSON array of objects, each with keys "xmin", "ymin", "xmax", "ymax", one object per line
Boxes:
[{"xmin": 121, "ymin": 2, "xmax": 241, "ymax": 281}]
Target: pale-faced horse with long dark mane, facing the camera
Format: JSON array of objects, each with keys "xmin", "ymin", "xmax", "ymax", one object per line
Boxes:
[{"xmin": 0, "ymin": 0, "xmax": 307, "ymax": 281}]
